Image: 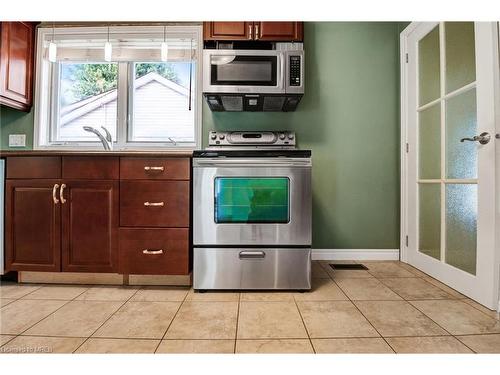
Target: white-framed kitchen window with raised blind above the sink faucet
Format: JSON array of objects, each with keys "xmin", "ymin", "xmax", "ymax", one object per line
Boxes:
[{"xmin": 35, "ymin": 25, "xmax": 202, "ymax": 150}]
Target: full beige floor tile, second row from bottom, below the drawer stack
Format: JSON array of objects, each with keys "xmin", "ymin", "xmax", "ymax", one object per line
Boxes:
[{"xmin": 92, "ymin": 302, "xmax": 181, "ymax": 339}]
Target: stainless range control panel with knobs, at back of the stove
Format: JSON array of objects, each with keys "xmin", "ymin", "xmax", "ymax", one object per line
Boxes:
[{"xmin": 208, "ymin": 131, "xmax": 295, "ymax": 148}]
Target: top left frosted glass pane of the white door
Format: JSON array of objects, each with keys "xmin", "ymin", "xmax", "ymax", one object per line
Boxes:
[{"xmin": 418, "ymin": 26, "xmax": 440, "ymax": 105}]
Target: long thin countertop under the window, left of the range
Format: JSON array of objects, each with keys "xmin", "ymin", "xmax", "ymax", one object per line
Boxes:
[{"xmin": 0, "ymin": 150, "xmax": 193, "ymax": 158}]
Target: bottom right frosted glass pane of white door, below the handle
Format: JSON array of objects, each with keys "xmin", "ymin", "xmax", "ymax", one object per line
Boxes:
[{"xmin": 446, "ymin": 184, "xmax": 477, "ymax": 275}]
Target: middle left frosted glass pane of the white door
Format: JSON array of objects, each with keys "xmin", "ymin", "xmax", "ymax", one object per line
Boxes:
[{"xmin": 418, "ymin": 103, "xmax": 441, "ymax": 179}]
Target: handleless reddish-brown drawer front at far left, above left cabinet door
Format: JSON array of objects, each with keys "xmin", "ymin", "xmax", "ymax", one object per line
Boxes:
[{"xmin": 7, "ymin": 156, "xmax": 61, "ymax": 178}]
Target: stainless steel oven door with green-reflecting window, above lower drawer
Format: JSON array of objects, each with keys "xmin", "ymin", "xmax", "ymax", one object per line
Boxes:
[{"xmin": 193, "ymin": 158, "xmax": 311, "ymax": 246}]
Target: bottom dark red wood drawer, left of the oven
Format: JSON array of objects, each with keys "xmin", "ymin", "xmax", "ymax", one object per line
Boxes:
[{"xmin": 119, "ymin": 228, "xmax": 189, "ymax": 275}]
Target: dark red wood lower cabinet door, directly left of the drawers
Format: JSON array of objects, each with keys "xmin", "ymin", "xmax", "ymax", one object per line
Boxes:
[{"xmin": 61, "ymin": 180, "xmax": 119, "ymax": 272}]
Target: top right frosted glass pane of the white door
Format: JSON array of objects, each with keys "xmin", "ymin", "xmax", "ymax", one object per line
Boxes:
[{"xmin": 444, "ymin": 22, "xmax": 476, "ymax": 93}]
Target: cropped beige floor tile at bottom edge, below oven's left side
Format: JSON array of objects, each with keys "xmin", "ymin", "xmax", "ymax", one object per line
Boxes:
[{"xmin": 156, "ymin": 340, "xmax": 234, "ymax": 354}]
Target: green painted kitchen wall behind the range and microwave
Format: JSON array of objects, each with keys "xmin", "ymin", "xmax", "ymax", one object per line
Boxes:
[{"xmin": 0, "ymin": 22, "xmax": 405, "ymax": 249}]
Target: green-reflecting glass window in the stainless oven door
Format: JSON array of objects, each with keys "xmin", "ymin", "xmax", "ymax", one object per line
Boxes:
[{"xmin": 215, "ymin": 177, "xmax": 290, "ymax": 224}]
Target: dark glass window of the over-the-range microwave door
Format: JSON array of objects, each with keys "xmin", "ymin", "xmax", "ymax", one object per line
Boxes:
[{"xmin": 210, "ymin": 55, "xmax": 278, "ymax": 86}]
